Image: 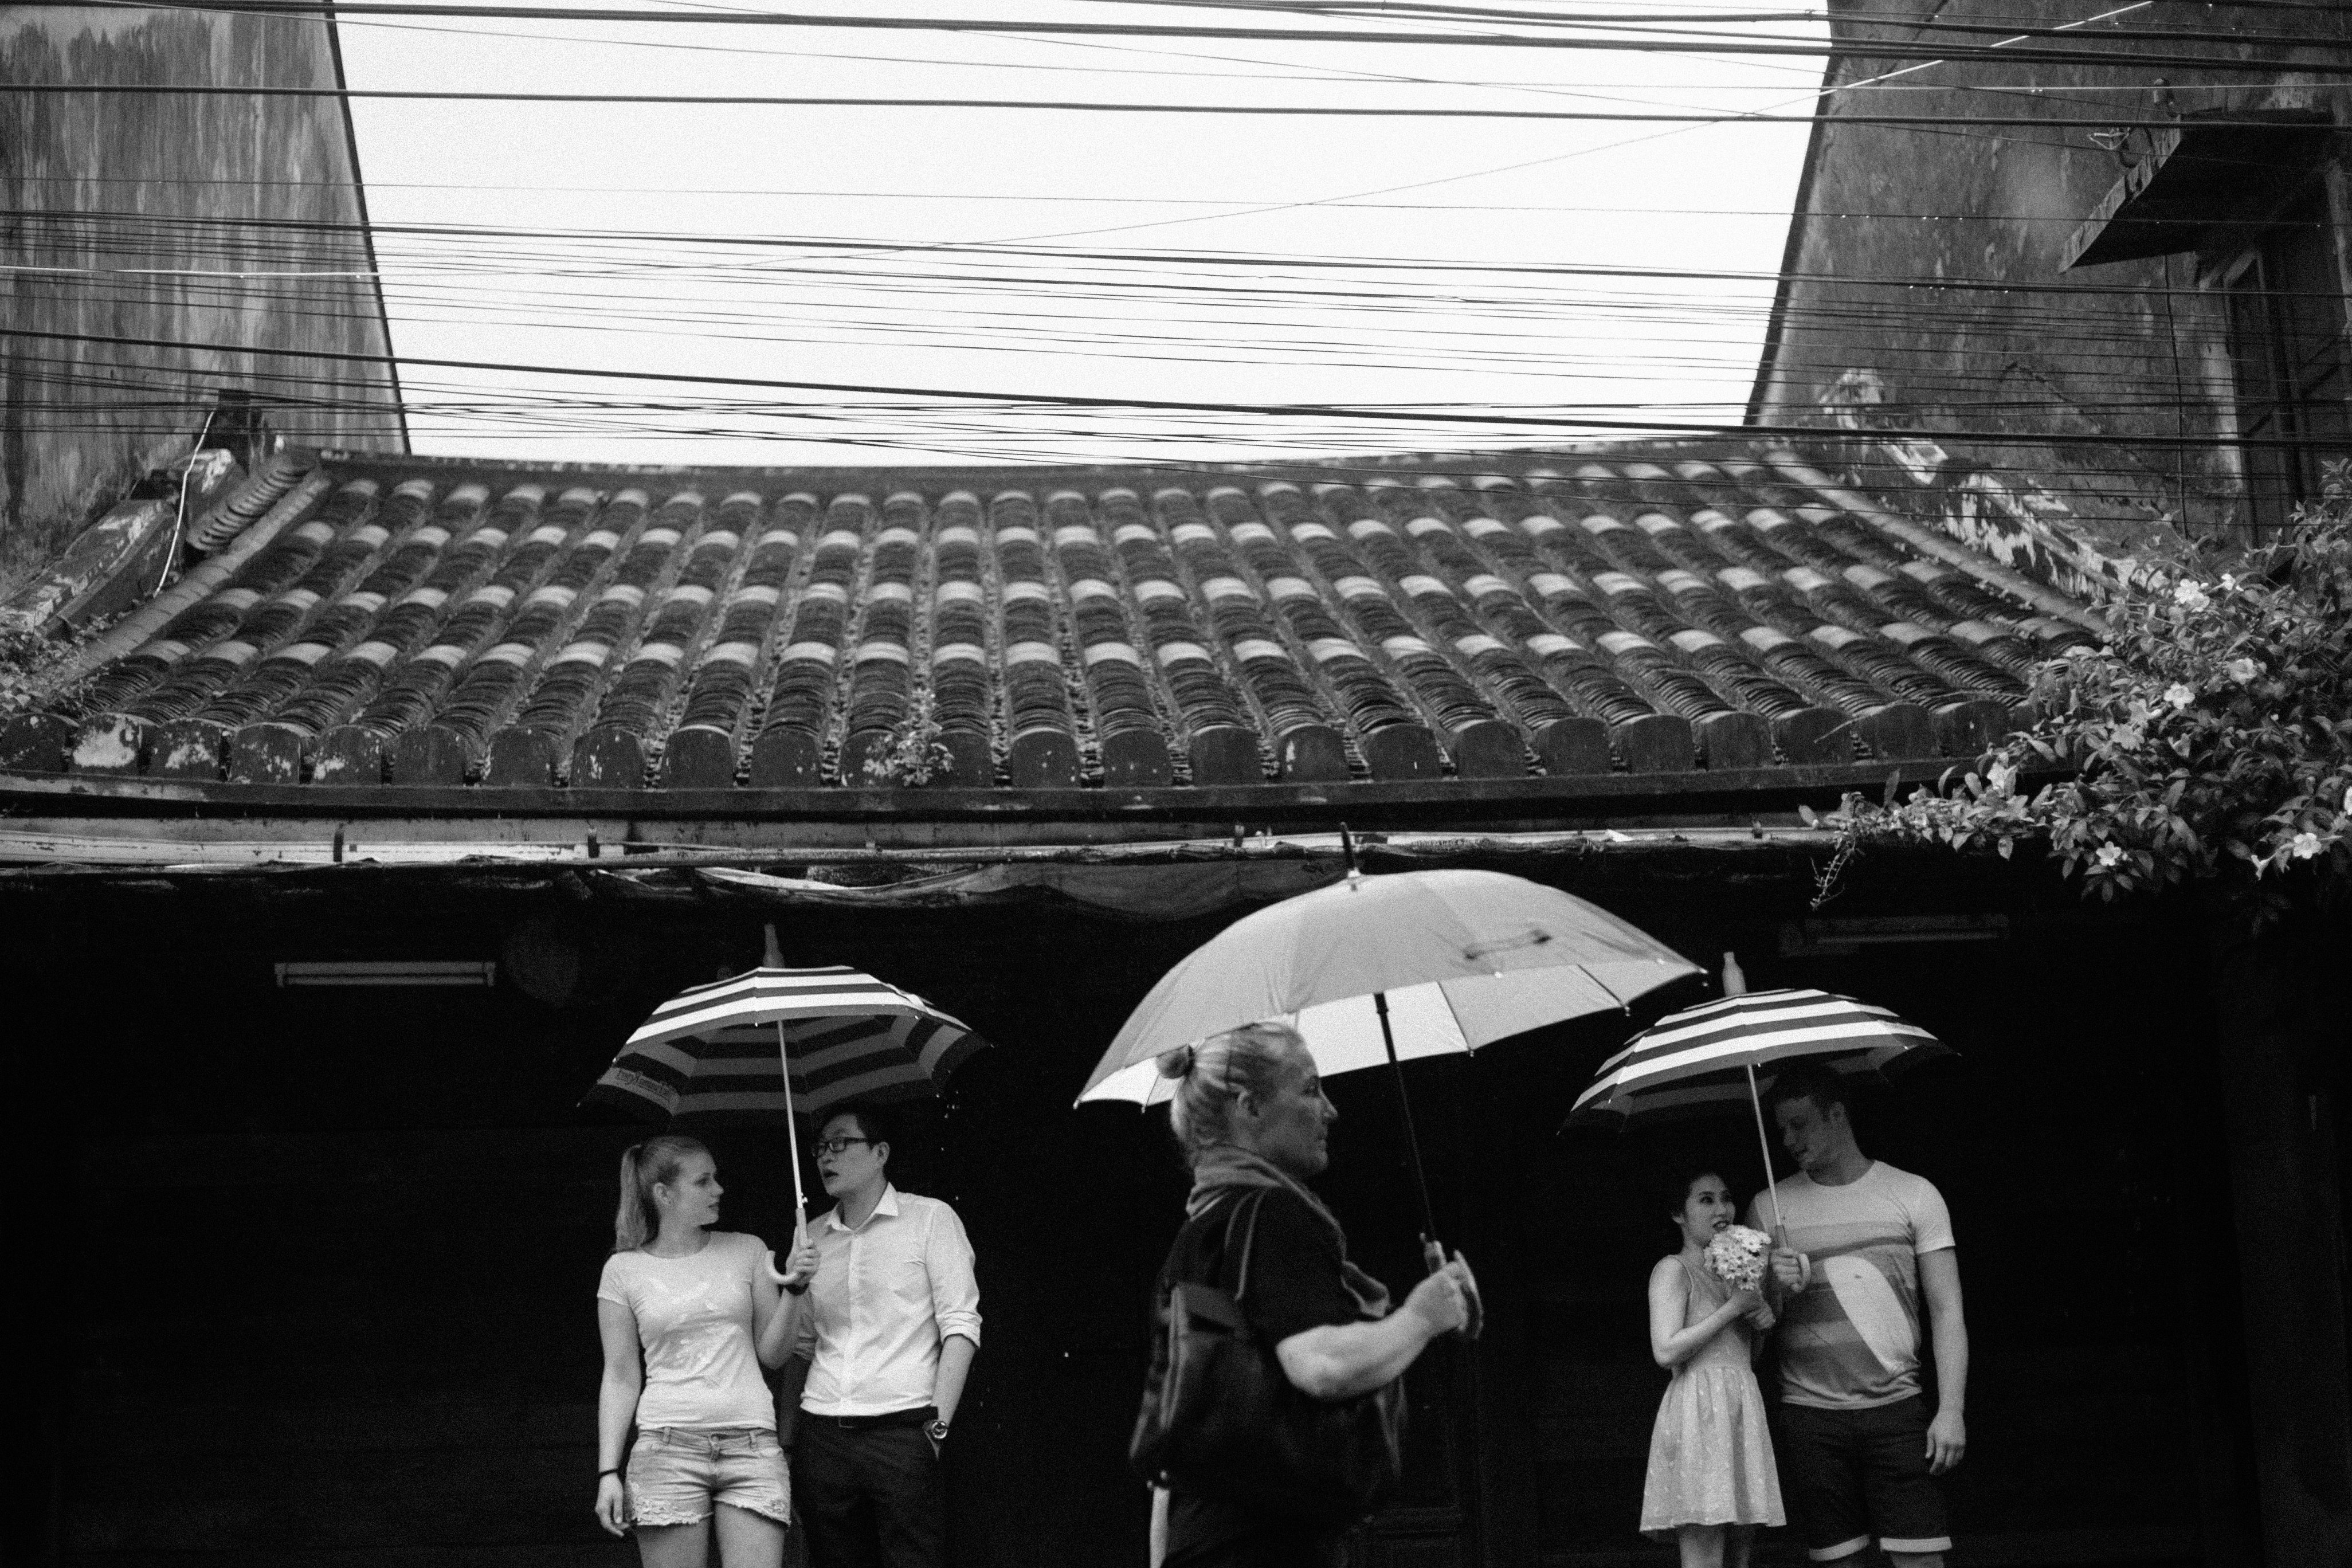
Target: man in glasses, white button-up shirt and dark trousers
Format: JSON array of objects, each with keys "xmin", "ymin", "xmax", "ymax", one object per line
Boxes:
[{"xmin": 793, "ymin": 1105, "xmax": 981, "ymax": 1568}]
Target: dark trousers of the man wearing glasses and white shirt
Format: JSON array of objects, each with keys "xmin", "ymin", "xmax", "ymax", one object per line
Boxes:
[{"xmin": 793, "ymin": 1413, "xmax": 948, "ymax": 1568}]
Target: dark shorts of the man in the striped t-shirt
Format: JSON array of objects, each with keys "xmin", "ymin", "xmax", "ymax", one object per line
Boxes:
[{"xmin": 1778, "ymin": 1399, "xmax": 1952, "ymax": 1563}]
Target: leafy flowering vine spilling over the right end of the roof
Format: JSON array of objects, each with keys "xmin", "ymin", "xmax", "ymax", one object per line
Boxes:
[{"xmin": 1816, "ymin": 463, "xmax": 2352, "ymax": 919}]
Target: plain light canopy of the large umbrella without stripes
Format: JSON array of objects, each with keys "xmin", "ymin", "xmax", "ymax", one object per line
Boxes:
[{"xmin": 1077, "ymin": 870, "xmax": 1700, "ymax": 1105}]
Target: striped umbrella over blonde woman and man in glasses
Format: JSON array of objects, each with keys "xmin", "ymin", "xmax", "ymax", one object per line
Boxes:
[{"xmin": 597, "ymin": 926, "xmax": 988, "ymax": 1199}]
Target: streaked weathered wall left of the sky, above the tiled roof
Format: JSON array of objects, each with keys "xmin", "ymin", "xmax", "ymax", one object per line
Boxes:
[{"xmin": 0, "ymin": 7, "xmax": 407, "ymax": 597}]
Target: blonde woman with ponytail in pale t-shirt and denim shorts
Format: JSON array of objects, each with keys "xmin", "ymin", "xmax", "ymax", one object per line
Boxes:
[{"xmin": 595, "ymin": 1133, "xmax": 816, "ymax": 1568}]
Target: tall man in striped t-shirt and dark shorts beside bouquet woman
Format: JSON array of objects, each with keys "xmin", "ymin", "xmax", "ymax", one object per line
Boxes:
[{"xmin": 1747, "ymin": 1065, "xmax": 1969, "ymax": 1568}]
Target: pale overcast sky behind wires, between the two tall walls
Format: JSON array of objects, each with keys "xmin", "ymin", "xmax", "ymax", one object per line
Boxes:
[{"xmin": 341, "ymin": 0, "xmax": 1820, "ymax": 463}]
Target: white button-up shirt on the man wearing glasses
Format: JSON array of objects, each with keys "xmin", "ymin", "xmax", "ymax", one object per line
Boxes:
[{"xmin": 799, "ymin": 1187, "xmax": 981, "ymax": 1415}]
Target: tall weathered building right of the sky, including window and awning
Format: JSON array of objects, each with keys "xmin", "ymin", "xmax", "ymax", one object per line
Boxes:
[{"xmin": 1750, "ymin": 0, "xmax": 2352, "ymax": 557}]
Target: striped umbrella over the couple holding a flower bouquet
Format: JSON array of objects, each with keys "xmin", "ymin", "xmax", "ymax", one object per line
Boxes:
[{"xmin": 1569, "ymin": 982, "xmax": 1952, "ymax": 1222}]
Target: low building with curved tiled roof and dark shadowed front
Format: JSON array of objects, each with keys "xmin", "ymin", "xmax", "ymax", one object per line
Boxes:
[{"xmin": 0, "ymin": 437, "xmax": 2345, "ymax": 1568}]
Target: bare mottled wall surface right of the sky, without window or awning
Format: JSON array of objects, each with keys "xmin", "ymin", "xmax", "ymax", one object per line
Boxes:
[{"xmin": 1755, "ymin": 0, "xmax": 2352, "ymax": 543}]
